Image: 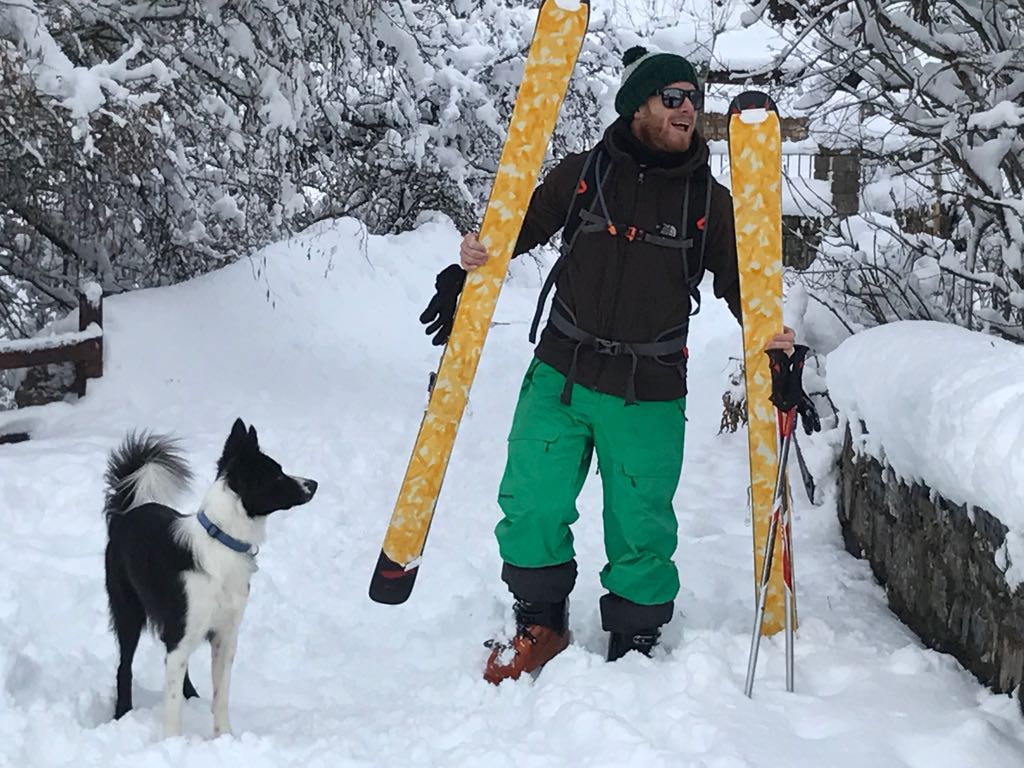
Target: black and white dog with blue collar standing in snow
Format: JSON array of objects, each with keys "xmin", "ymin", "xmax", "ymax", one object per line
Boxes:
[{"xmin": 103, "ymin": 419, "xmax": 316, "ymax": 736}]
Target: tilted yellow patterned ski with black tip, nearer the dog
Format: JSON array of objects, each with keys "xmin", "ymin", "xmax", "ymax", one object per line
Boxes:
[{"xmin": 370, "ymin": 0, "xmax": 590, "ymax": 604}]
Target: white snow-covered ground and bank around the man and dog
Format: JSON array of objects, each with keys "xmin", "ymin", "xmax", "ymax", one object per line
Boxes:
[{"xmin": 0, "ymin": 220, "xmax": 1024, "ymax": 768}]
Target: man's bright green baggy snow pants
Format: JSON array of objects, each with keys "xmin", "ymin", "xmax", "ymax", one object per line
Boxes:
[{"xmin": 495, "ymin": 359, "xmax": 686, "ymax": 605}]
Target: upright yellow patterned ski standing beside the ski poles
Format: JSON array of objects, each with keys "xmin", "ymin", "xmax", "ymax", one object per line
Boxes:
[{"xmin": 729, "ymin": 91, "xmax": 796, "ymax": 635}]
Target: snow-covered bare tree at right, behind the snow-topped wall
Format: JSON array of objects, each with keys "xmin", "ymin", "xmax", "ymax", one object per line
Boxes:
[{"xmin": 755, "ymin": 0, "xmax": 1024, "ymax": 339}]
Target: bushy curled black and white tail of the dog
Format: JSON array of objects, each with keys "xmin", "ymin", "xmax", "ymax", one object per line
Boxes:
[{"xmin": 103, "ymin": 432, "xmax": 193, "ymax": 525}]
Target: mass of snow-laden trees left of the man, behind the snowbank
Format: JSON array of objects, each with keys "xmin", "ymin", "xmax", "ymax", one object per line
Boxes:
[{"xmin": 0, "ymin": 0, "xmax": 737, "ymax": 358}]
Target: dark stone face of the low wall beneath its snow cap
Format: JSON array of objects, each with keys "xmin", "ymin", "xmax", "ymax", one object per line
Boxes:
[{"xmin": 838, "ymin": 429, "xmax": 1024, "ymax": 711}]
